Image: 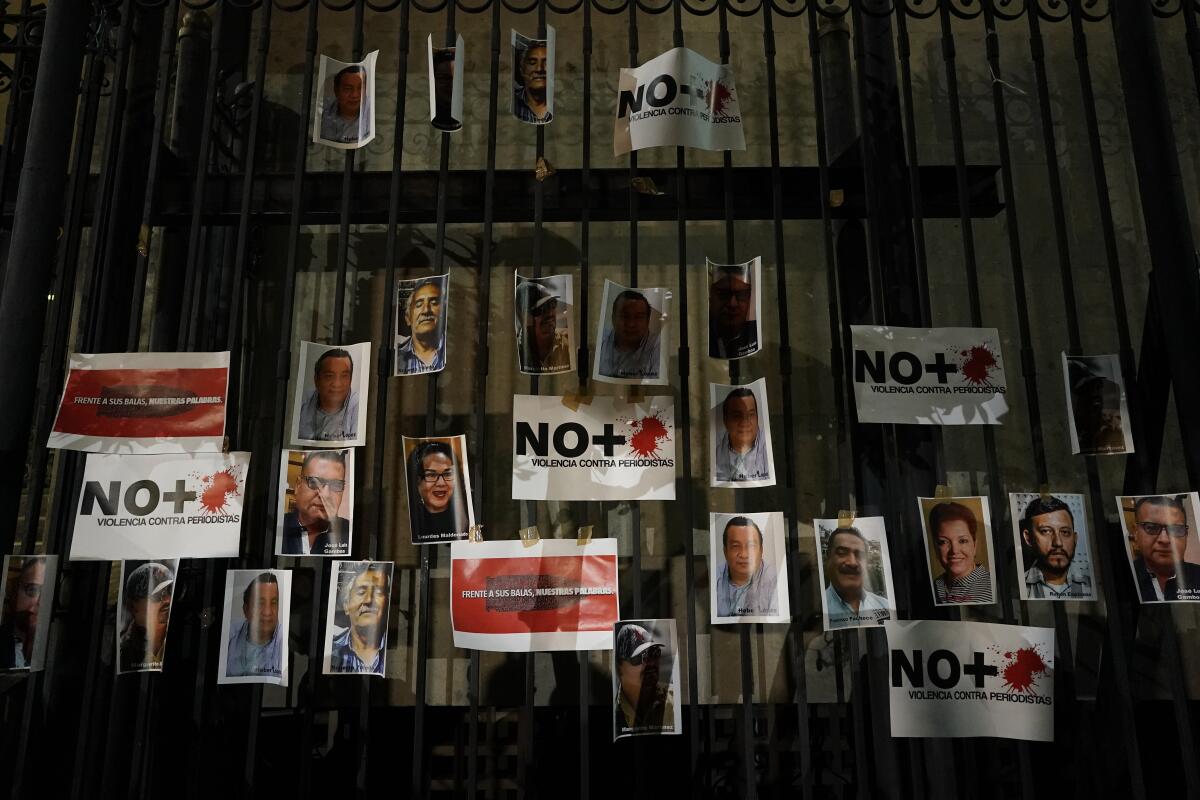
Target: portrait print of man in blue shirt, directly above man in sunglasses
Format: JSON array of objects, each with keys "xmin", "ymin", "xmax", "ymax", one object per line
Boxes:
[{"xmin": 292, "ymin": 342, "xmax": 371, "ymax": 447}]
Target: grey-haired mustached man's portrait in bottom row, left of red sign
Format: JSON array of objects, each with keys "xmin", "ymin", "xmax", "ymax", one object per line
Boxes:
[{"xmin": 329, "ymin": 561, "xmax": 391, "ymax": 675}]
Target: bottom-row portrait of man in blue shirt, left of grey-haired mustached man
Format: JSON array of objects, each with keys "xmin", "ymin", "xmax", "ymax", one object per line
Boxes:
[{"xmin": 217, "ymin": 570, "xmax": 292, "ymax": 686}]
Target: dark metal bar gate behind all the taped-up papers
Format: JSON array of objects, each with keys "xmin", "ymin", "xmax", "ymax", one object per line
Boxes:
[{"xmin": 0, "ymin": 0, "xmax": 1200, "ymax": 798}]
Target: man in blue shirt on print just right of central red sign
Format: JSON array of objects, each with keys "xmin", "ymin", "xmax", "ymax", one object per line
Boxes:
[{"xmin": 716, "ymin": 517, "xmax": 779, "ymax": 616}]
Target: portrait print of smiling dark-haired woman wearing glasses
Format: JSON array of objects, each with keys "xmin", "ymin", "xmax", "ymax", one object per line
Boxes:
[{"xmin": 404, "ymin": 435, "xmax": 475, "ymax": 545}]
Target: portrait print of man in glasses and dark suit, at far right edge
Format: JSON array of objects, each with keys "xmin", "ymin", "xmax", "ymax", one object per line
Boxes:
[{"xmin": 1117, "ymin": 492, "xmax": 1200, "ymax": 603}]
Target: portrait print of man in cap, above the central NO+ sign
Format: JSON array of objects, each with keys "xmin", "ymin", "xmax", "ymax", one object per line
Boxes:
[{"xmin": 512, "ymin": 273, "xmax": 575, "ymax": 375}]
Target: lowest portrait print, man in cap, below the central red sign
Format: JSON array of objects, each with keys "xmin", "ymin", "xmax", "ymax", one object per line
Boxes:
[{"xmin": 614, "ymin": 622, "xmax": 674, "ymax": 736}]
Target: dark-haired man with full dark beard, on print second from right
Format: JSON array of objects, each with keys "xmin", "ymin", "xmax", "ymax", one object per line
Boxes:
[{"xmin": 1021, "ymin": 497, "xmax": 1092, "ymax": 600}]
